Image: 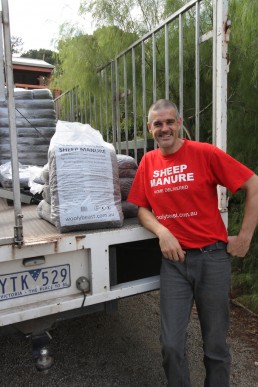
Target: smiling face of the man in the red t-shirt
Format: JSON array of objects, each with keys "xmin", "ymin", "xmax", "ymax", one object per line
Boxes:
[{"xmin": 147, "ymin": 108, "xmax": 182, "ymax": 154}]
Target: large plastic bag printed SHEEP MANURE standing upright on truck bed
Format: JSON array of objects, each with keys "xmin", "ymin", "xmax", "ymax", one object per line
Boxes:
[{"xmin": 48, "ymin": 121, "xmax": 124, "ymax": 232}]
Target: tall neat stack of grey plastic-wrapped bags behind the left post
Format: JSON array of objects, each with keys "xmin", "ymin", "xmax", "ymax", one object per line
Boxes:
[{"xmin": 0, "ymin": 88, "xmax": 56, "ymax": 166}]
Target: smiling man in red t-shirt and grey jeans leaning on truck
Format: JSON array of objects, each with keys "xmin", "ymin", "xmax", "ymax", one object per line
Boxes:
[{"xmin": 128, "ymin": 100, "xmax": 258, "ymax": 387}]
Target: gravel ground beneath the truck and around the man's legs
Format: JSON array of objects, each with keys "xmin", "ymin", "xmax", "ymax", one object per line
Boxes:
[{"xmin": 0, "ymin": 291, "xmax": 258, "ymax": 387}]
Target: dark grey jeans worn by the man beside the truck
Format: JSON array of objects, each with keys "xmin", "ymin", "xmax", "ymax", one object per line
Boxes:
[{"xmin": 160, "ymin": 242, "xmax": 231, "ymax": 387}]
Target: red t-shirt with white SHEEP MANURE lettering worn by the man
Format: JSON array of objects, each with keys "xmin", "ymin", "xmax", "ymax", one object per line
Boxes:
[{"xmin": 127, "ymin": 140, "xmax": 254, "ymax": 248}]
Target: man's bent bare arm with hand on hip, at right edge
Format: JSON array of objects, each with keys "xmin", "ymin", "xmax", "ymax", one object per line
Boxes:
[{"xmin": 227, "ymin": 175, "xmax": 258, "ymax": 257}]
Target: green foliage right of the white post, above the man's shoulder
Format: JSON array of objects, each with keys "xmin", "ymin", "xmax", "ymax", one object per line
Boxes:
[{"xmin": 228, "ymin": 0, "xmax": 258, "ymax": 170}]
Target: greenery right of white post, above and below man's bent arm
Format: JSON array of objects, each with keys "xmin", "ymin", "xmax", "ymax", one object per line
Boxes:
[{"xmin": 228, "ymin": 0, "xmax": 258, "ymax": 313}]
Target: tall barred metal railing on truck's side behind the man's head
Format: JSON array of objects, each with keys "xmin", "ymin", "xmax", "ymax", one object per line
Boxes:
[{"xmin": 55, "ymin": 0, "xmax": 228, "ymax": 167}]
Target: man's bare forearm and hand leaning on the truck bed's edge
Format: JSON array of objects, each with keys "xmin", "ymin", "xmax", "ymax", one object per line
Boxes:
[{"xmin": 138, "ymin": 207, "xmax": 185, "ymax": 262}]
